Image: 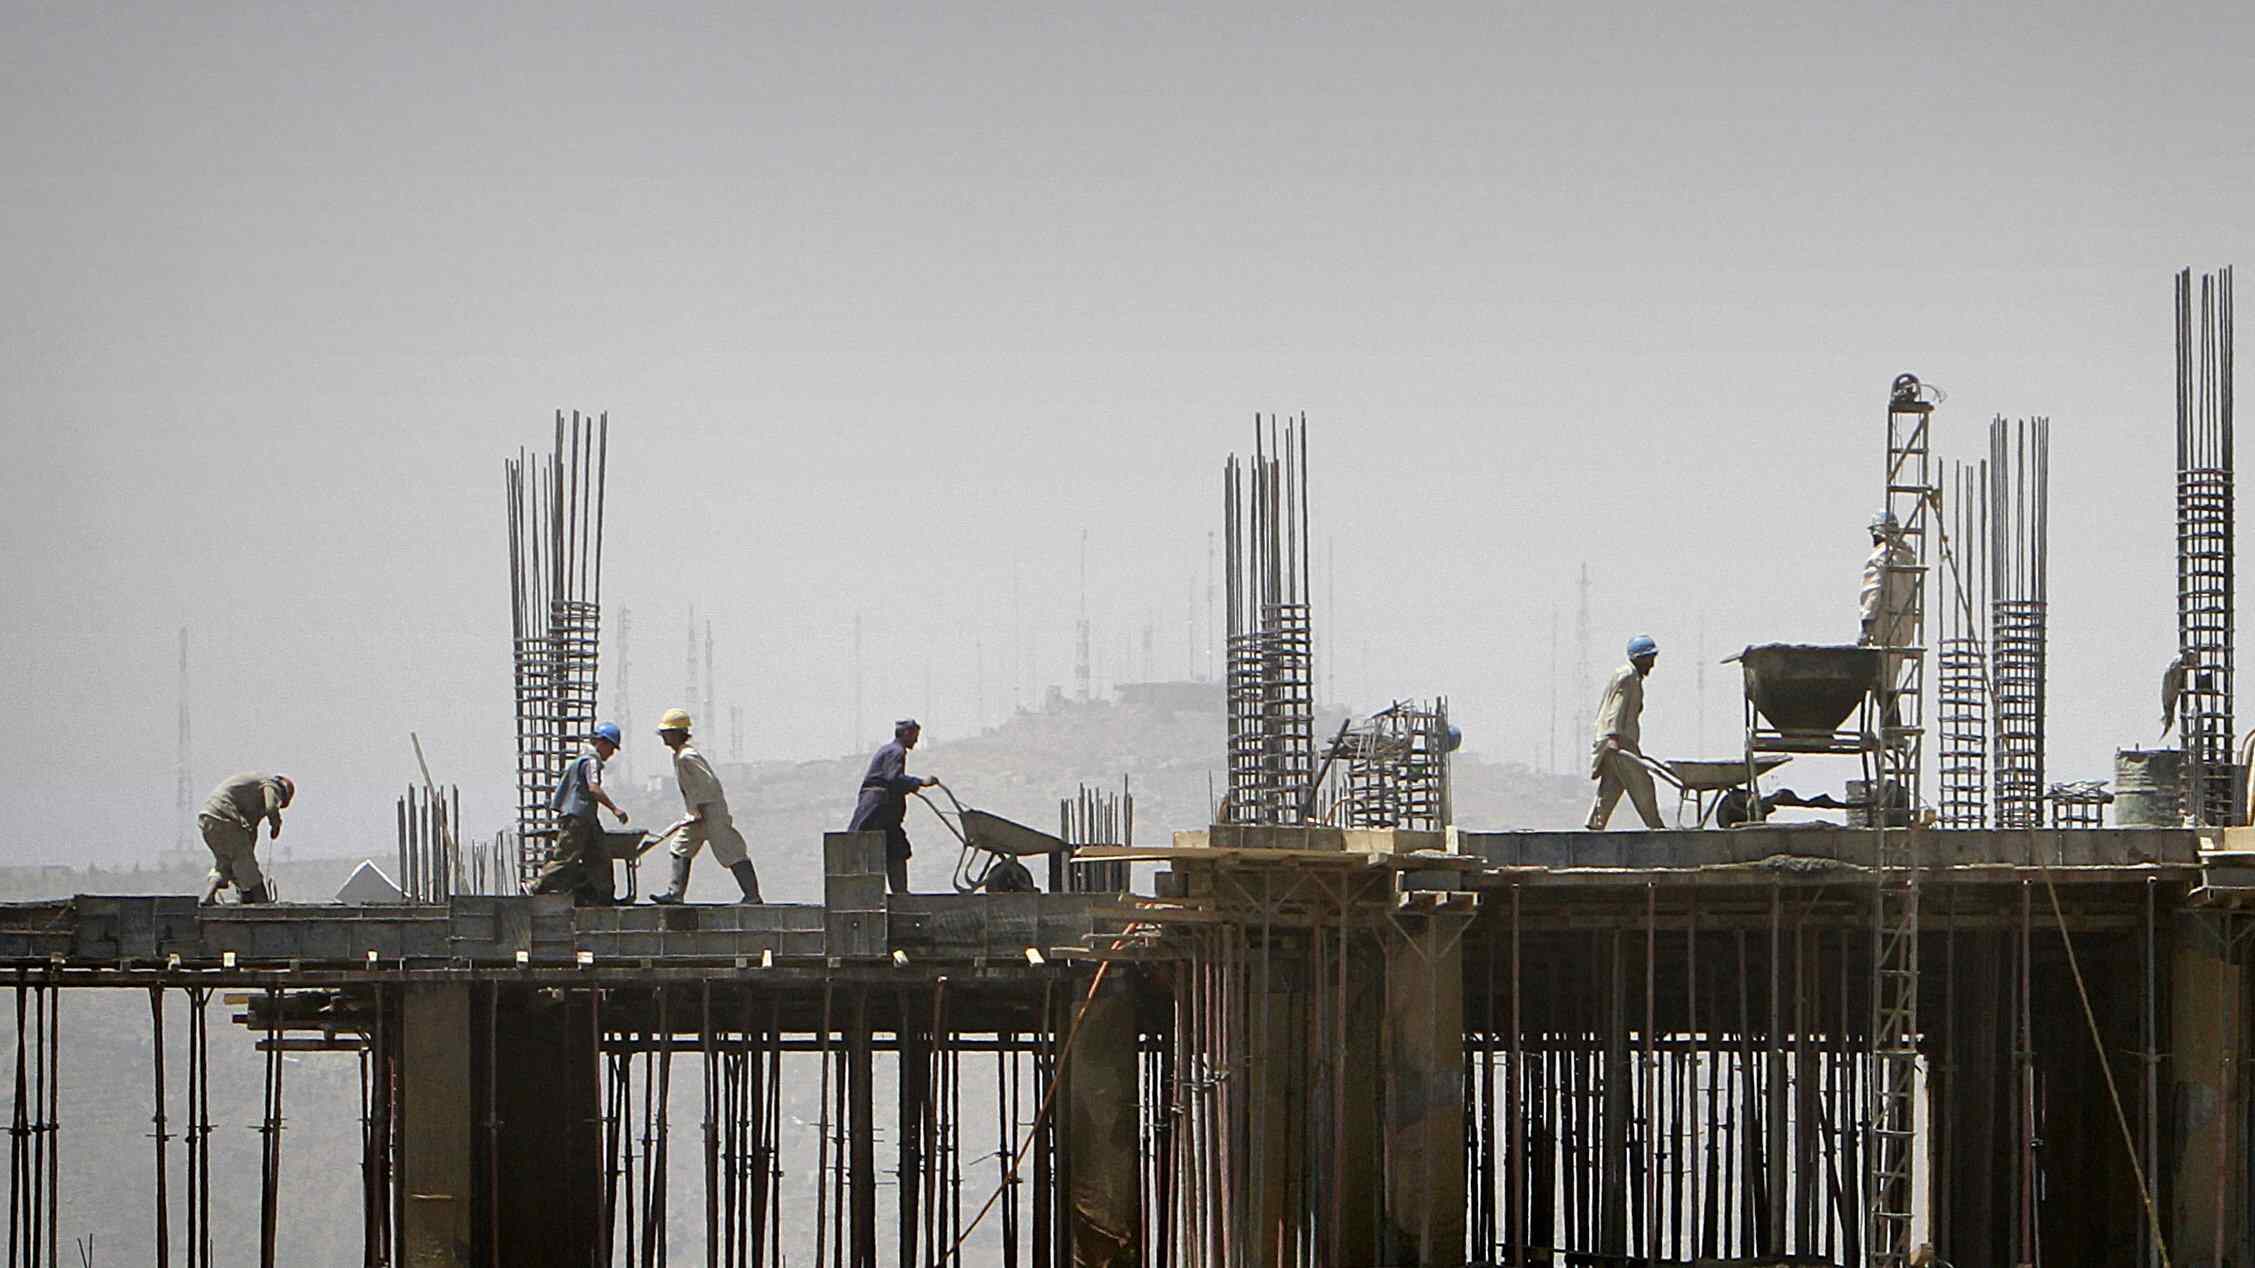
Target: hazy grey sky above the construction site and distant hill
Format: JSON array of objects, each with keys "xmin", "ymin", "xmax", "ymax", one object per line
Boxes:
[{"xmin": 0, "ymin": 5, "xmax": 2255, "ymax": 860}]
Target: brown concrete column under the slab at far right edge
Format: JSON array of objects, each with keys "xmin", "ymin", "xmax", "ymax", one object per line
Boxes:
[{"xmin": 2163, "ymin": 914, "xmax": 2248, "ymax": 1268}]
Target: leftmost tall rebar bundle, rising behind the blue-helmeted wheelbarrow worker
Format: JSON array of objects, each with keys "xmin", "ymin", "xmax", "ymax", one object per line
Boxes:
[{"xmin": 503, "ymin": 411, "xmax": 611, "ymax": 884}]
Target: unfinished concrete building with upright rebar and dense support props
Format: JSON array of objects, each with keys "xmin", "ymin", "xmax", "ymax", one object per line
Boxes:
[{"xmin": 0, "ymin": 268, "xmax": 2255, "ymax": 1268}]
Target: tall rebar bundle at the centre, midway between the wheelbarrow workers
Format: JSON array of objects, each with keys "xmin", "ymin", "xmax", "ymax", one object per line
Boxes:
[{"xmin": 1220, "ymin": 417, "xmax": 1315, "ymax": 824}]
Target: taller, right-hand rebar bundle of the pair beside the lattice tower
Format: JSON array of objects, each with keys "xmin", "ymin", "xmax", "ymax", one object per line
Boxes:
[{"xmin": 1989, "ymin": 417, "xmax": 2052, "ymax": 828}]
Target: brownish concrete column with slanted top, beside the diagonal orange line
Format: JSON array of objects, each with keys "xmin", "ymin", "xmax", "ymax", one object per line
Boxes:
[{"xmin": 1060, "ymin": 966, "xmax": 1141, "ymax": 1268}]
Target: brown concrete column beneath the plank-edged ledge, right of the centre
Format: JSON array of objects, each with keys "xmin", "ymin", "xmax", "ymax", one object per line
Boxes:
[{"xmin": 1385, "ymin": 914, "xmax": 1468, "ymax": 1268}]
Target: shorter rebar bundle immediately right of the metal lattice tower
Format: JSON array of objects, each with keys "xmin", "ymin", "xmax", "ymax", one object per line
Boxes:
[{"xmin": 1935, "ymin": 463, "xmax": 1989, "ymax": 828}]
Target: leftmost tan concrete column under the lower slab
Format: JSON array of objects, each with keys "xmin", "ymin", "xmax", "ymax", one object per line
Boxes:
[{"xmin": 399, "ymin": 984, "xmax": 476, "ymax": 1268}]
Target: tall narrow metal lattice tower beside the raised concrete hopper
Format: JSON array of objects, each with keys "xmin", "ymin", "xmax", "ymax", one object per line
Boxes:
[{"xmin": 1865, "ymin": 375, "xmax": 1937, "ymax": 1268}]
